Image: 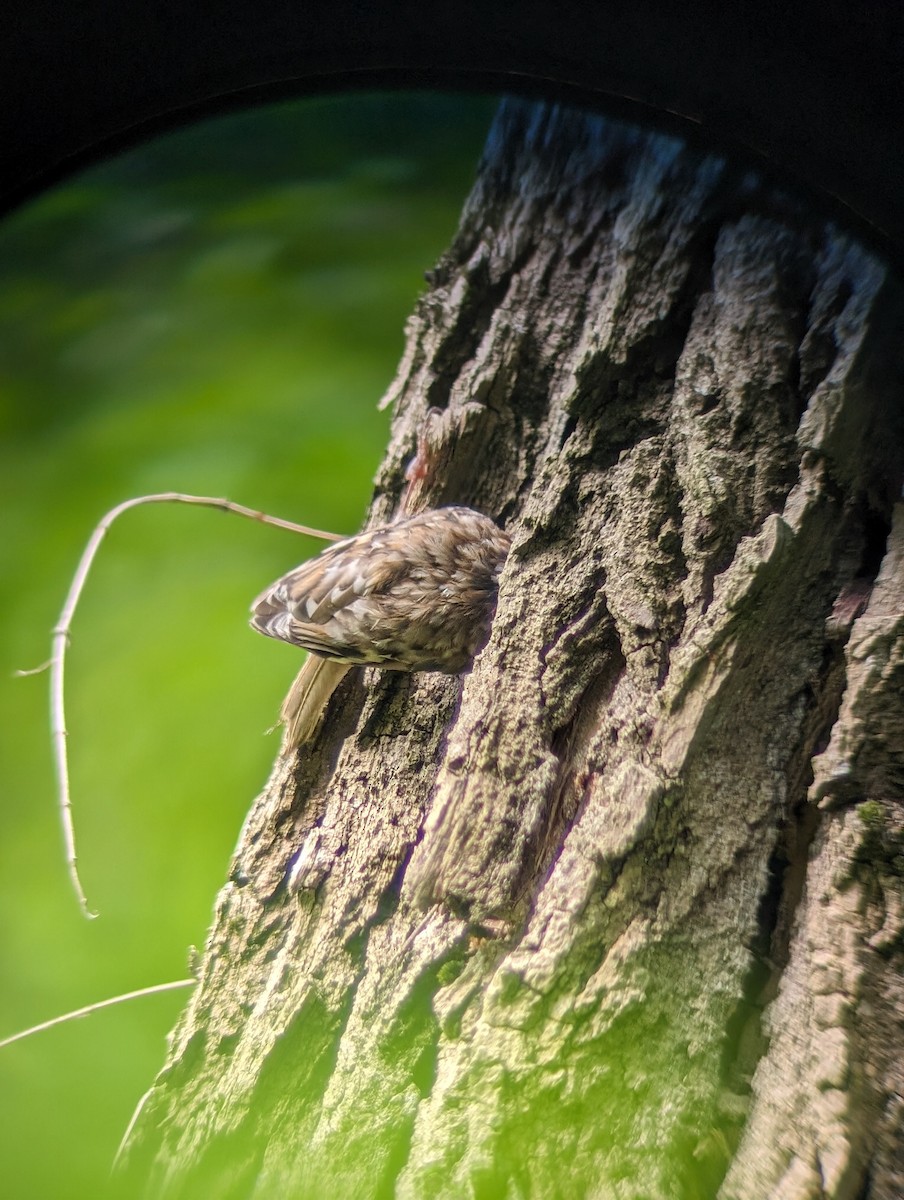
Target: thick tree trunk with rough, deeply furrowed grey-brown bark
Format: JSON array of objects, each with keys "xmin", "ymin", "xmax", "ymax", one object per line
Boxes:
[{"xmin": 125, "ymin": 103, "xmax": 904, "ymax": 1200}]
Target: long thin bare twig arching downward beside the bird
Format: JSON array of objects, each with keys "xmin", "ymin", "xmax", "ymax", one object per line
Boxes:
[{"xmin": 18, "ymin": 492, "xmax": 345, "ymax": 918}]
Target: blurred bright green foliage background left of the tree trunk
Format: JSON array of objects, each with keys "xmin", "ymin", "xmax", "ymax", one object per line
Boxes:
[{"xmin": 0, "ymin": 88, "xmax": 493, "ymax": 1200}]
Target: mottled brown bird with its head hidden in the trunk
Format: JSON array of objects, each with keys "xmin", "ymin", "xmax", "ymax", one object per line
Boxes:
[{"xmin": 251, "ymin": 508, "xmax": 510, "ymax": 752}]
